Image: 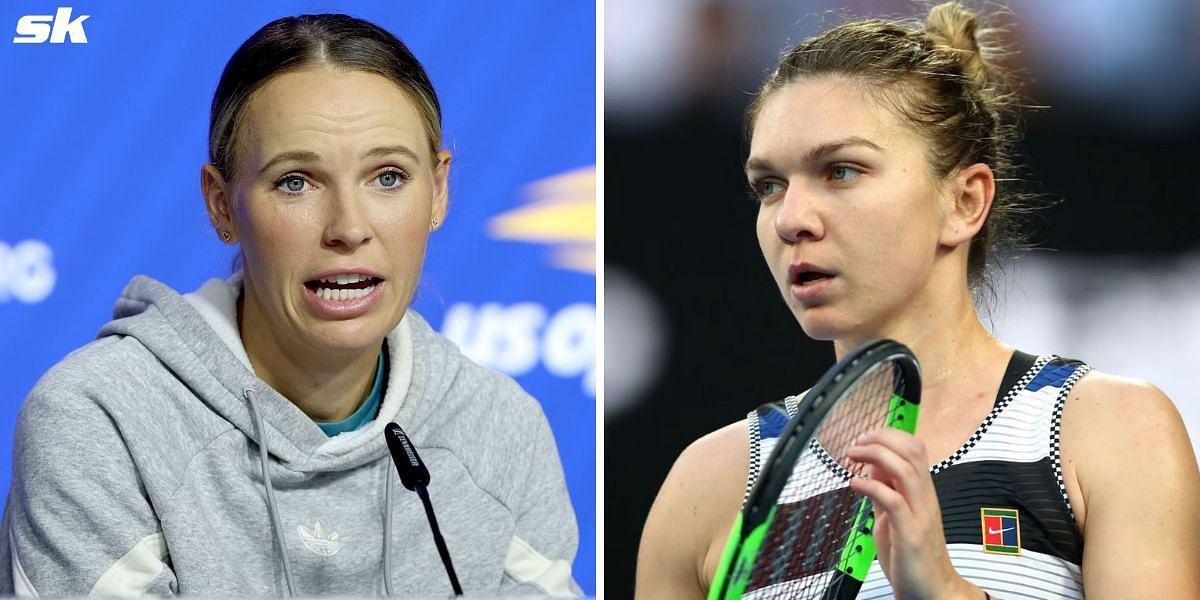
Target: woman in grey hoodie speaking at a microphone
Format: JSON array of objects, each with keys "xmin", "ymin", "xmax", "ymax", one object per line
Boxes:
[{"xmin": 0, "ymin": 14, "xmax": 578, "ymax": 598}]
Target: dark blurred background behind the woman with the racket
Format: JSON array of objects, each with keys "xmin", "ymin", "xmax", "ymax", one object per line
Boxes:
[{"xmin": 604, "ymin": 0, "xmax": 1200, "ymax": 598}]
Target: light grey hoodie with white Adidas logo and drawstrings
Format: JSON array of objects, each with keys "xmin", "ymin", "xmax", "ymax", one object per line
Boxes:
[{"xmin": 0, "ymin": 276, "xmax": 578, "ymax": 598}]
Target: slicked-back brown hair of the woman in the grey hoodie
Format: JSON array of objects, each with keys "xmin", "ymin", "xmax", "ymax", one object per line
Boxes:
[{"xmin": 209, "ymin": 14, "xmax": 442, "ymax": 180}]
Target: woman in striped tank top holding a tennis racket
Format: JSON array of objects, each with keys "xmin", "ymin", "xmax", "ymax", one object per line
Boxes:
[{"xmin": 637, "ymin": 2, "xmax": 1200, "ymax": 599}]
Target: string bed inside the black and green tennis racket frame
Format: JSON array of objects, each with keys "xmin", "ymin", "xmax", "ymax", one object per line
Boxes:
[{"xmin": 745, "ymin": 362, "xmax": 900, "ymax": 599}]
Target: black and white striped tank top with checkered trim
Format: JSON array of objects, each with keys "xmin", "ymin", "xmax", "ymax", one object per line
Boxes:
[{"xmin": 743, "ymin": 352, "xmax": 1091, "ymax": 600}]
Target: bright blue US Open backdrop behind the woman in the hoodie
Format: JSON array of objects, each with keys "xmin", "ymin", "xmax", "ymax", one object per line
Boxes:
[{"xmin": 0, "ymin": 0, "xmax": 596, "ymax": 594}]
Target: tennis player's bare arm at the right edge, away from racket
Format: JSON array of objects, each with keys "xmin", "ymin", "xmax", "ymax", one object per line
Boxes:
[{"xmin": 1062, "ymin": 373, "xmax": 1200, "ymax": 600}]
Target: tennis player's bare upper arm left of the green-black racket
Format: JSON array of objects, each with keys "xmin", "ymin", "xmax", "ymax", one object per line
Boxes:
[{"xmin": 637, "ymin": 420, "xmax": 750, "ymax": 599}]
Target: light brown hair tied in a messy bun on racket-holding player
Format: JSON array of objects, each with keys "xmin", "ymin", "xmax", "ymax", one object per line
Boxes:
[{"xmin": 746, "ymin": 2, "xmax": 1033, "ymax": 300}]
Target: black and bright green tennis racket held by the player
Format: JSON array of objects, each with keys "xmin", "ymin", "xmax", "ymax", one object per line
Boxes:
[{"xmin": 708, "ymin": 340, "xmax": 920, "ymax": 600}]
